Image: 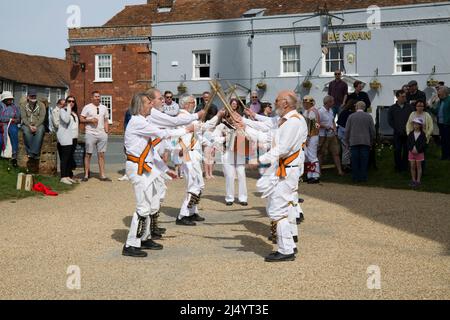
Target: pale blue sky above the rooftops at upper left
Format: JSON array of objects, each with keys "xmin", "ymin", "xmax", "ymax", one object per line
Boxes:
[{"xmin": 0, "ymin": 0, "xmax": 147, "ymax": 58}]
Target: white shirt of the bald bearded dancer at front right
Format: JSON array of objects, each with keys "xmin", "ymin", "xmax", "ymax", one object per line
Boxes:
[{"xmin": 245, "ymin": 110, "xmax": 308, "ymax": 166}]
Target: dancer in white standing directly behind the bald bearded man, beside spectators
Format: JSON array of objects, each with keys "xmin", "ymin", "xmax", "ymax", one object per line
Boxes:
[{"xmin": 303, "ymin": 96, "xmax": 320, "ymax": 184}]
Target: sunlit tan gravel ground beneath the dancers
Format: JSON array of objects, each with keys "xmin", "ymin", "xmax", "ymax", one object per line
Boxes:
[{"xmin": 0, "ymin": 170, "xmax": 450, "ymax": 300}]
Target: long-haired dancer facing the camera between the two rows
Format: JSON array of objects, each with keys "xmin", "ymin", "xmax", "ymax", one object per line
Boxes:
[{"xmin": 214, "ymin": 99, "xmax": 249, "ymax": 206}]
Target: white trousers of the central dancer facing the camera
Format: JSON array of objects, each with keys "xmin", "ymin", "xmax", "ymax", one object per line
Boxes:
[{"xmin": 222, "ymin": 150, "xmax": 248, "ymax": 202}]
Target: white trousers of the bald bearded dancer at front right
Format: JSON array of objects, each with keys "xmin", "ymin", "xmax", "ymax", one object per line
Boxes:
[{"xmin": 266, "ymin": 168, "xmax": 300, "ymax": 254}]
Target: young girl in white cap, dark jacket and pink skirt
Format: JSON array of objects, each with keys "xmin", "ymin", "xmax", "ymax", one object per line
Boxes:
[{"xmin": 408, "ymin": 118, "xmax": 427, "ymax": 188}]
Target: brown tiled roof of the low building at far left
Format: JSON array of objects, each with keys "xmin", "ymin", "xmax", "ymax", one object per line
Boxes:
[{"xmin": 0, "ymin": 50, "xmax": 69, "ymax": 88}]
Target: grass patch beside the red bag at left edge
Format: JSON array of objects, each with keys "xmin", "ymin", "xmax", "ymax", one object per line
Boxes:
[{"xmin": 0, "ymin": 159, "xmax": 74, "ymax": 201}]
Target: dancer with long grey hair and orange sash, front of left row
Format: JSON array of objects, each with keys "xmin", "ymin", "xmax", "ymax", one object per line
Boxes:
[{"xmin": 122, "ymin": 89, "xmax": 199, "ymax": 257}]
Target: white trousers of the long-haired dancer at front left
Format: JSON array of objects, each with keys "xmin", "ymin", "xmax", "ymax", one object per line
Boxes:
[{"xmin": 126, "ymin": 162, "xmax": 164, "ymax": 248}]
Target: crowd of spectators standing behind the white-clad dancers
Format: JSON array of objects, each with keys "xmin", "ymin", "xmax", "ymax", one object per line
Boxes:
[{"xmin": 0, "ymin": 70, "xmax": 450, "ymax": 190}]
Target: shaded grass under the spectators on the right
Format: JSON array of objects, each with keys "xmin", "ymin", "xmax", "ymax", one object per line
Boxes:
[{"xmin": 321, "ymin": 142, "xmax": 450, "ymax": 194}]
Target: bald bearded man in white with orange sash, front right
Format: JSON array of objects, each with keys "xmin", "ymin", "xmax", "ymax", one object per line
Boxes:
[{"xmin": 237, "ymin": 91, "xmax": 308, "ymax": 262}]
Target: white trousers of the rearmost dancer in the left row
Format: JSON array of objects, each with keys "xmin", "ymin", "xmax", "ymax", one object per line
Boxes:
[{"xmin": 178, "ymin": 161, "xmax": 205, "ymax": 219}]
